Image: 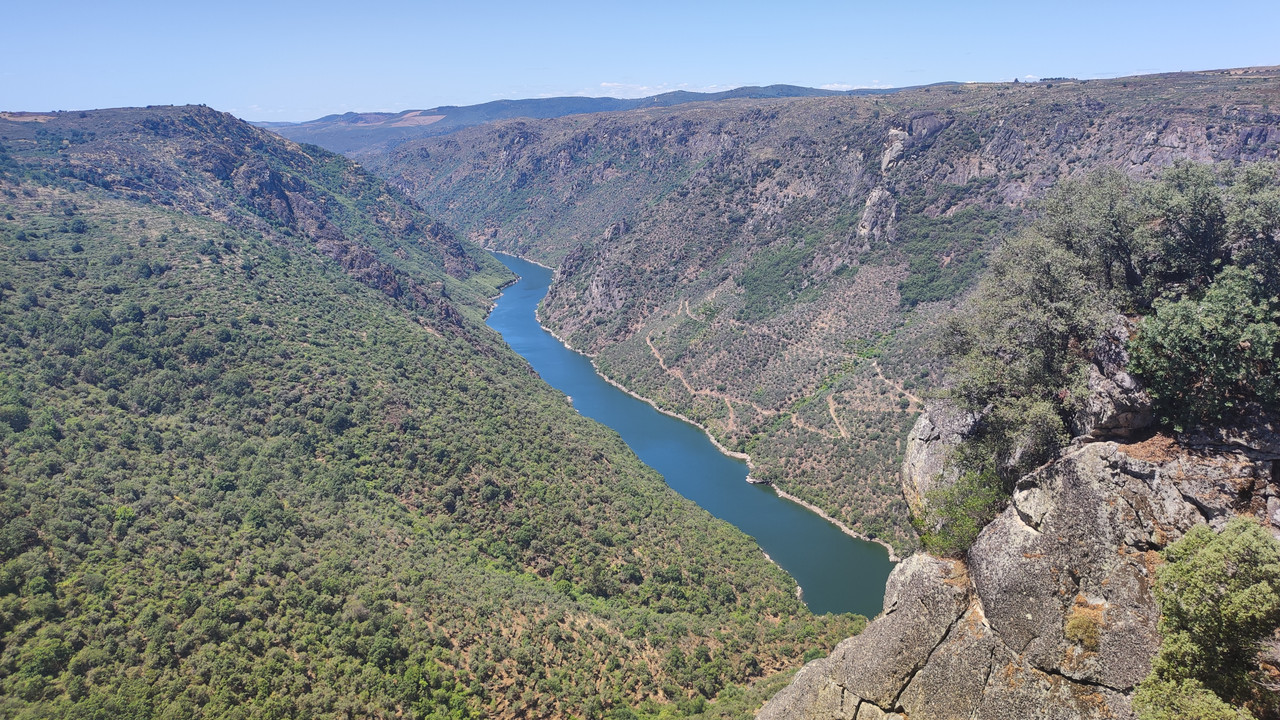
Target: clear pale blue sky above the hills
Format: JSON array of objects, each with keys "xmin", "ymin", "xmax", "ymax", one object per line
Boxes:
[{"xmin": 0, "ymin": 0, "xmax": 1280, "ymax": 120}]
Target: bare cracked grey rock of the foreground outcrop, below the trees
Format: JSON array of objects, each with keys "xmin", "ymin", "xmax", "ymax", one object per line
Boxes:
[{"xmin": 758, "ymin": 436, "xmax": 1280, "ymax": 720}]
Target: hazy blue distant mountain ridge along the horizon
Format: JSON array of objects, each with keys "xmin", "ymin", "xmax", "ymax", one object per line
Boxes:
[{"xmin": 253, "ymin": 83, "xmax": 931, "ymax": 156}]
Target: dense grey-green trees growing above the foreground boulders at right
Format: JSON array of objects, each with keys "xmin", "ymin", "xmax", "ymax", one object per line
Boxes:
[{"xmin": 925, "ymin": 163, "xmax": 1280, "ymax": 552}]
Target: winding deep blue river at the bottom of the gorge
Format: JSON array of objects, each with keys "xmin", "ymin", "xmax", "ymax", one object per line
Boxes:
[{"xmin": 488, "ymin": 255, "xmax": 892, "ymax": 609}]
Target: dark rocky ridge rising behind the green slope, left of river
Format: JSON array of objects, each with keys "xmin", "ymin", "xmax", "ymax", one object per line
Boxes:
[{"xmin": 0, "ymin": 105, "xmax": 511, "ymax": 322}]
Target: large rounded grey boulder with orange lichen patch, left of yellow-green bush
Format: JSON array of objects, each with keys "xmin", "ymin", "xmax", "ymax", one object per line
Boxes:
[{"xmin": 969, "ymin": 443, "xmax": 1187, "ymax": 692}]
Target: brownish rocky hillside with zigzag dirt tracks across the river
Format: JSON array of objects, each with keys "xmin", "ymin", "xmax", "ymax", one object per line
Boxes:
[{"xmin": 364, "ymin": 68, "xmax": 1280, "ymax": 548}]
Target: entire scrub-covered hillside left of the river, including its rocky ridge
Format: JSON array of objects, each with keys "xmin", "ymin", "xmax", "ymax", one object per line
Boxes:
[{"xmin": 0, "ymin": 108, "xmax": 860, "ymax": 717}]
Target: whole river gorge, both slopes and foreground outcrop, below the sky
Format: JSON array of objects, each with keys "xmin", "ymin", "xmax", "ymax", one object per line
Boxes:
[{"xmin": 0, "ymin": 61, "xmax": 1280, "ymax": 720}]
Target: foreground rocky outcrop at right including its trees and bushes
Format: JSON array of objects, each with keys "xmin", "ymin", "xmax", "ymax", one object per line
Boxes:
[{"xmin": 759, "ymin": 161, "xmax": 1280, "ymax": 720}]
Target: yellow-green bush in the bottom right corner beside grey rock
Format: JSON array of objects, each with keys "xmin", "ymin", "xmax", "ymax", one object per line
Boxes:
[{"xmin": 1134, "ymin": 518, "xmax": 1280, "ymax": 720}]
